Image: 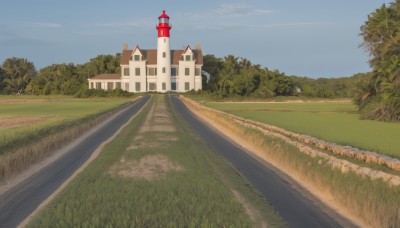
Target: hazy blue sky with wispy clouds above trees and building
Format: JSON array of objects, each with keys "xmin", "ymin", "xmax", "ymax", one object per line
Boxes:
[{"xmin": 0, "ymin": 0, "xmax": 392, "ymax": 78}]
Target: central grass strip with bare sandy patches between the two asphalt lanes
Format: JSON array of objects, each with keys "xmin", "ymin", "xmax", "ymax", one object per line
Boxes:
[{"xmin": 28, "ymin": 96, "xmax": 283, "ymax": 227}]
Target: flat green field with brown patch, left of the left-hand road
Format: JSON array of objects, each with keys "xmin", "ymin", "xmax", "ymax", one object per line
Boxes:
[{"xmin": 0, "ymin": 96, "xmax": 129, "ymax": 154}]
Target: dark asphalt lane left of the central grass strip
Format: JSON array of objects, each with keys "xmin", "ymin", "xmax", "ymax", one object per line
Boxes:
[{"xmin": 0, "ymin": 96, "xmax": 150, "ymax": 228}]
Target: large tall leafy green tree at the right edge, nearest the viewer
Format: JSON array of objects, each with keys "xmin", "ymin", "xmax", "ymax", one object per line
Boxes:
[{"xmin": 354, "ymin": 0, "xmax": 400, "ymax": 121}]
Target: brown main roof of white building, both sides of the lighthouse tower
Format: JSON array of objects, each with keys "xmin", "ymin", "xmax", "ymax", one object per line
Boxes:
[{"xmin": 121, "ymin": 46, "xmax": 203, "ymax": 65}]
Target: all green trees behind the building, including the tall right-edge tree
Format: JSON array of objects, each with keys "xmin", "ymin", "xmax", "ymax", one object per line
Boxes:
[{"xmin": 0, "ymin": 0, "xmax": 400, "ymax": 122}]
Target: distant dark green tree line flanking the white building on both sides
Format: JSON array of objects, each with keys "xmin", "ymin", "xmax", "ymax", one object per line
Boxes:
[{"xmin": 0, "ymin": 54, "xmax": 364, "ymax": 98}]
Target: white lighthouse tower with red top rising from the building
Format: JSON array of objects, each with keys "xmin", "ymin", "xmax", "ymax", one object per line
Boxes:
[{"xmin": 156, "ymin": 10, "xmax": 172, "ymax": 93}]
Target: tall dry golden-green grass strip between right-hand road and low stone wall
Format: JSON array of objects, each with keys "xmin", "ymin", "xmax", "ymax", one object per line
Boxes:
[{"xmin": 188, "ymin": 98, "xmax": 400, "ymax": 227}]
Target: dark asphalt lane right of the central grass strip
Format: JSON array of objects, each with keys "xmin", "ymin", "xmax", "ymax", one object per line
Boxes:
[{"xmin": 170, "ymin": 96, "xmax": 355, "ymax": 228}]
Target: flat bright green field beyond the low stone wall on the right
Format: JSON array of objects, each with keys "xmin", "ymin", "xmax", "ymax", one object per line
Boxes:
[{"xmin": 205, "ymin": 102, "xmax": 400, "ymax": 158}]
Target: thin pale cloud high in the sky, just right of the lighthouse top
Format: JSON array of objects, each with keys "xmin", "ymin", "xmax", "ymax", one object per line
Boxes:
[{"xmin": 193, "ymin": 3, "xmax": 272, "ymax": 18}]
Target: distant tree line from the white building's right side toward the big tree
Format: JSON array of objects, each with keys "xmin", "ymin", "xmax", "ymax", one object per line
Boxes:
[{"xmin": 203, "ymin": 55, "xmax": 367, "ymax": 98}]
